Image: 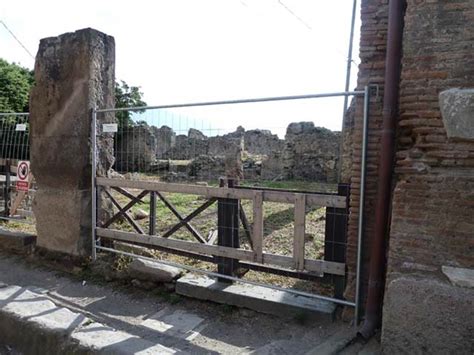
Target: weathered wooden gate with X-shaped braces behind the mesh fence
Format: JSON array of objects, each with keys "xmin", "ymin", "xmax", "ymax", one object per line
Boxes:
[{"xmin": 96, "ymin": 177, "xmax": 347, "ymax": 278}]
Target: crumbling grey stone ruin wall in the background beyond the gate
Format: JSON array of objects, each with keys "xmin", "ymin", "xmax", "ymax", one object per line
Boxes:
[{"xmin": 115, "ymin": 122, "xmax": 340, "ymax": 183}]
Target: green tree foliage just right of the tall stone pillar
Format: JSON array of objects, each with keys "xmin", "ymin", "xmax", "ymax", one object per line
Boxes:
[{"xmin": 115, "ymin": 80, "xmax": 146, "ymax": 127}]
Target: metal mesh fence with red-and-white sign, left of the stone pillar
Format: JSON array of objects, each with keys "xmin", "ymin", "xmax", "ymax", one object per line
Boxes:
[{"xmin": 0, "ymin": 113, "xmax": 35, "ymax": 224}]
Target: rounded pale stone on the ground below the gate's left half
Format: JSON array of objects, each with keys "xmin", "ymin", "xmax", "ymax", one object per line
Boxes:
[{"xmin": 128, "ymin": 259, "xmax": 183, "ymax": 282}]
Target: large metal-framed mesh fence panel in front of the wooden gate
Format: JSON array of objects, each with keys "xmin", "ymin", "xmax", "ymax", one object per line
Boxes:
[{"xmin": 92, "ymin": 87, "xmax": 369, "ymax": 323}]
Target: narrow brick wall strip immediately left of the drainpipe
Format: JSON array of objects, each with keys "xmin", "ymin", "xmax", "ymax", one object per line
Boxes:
[{"xmin": 341, "ymin": 0, "xmax": 388, "ymax": 305}]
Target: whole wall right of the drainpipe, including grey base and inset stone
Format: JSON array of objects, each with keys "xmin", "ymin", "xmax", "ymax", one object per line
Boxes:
[{"xmin": 381, "ymin": 0, "xmax": 474, "ymax": 354}]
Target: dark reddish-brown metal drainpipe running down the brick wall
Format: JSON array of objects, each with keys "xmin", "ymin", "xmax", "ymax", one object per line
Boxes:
[{"xmin": 359, "ymin": 0, "xmax": 405, "ymax": 339}]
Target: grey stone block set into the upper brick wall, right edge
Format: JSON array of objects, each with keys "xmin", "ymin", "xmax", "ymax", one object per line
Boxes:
[{"xmin": 439, "ymin": 89, "xmax": 474, "ymax": 141}]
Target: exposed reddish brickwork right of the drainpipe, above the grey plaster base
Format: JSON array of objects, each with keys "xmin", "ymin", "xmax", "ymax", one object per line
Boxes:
[{"xmin": 388, "ymin": 0, "xmax": 474, "ymax": 278}]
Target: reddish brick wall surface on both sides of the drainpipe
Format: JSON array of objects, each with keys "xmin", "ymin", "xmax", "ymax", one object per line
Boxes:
[{"xmin": 342, "ymin": 0, "xmax": 474, "ymax": 328}]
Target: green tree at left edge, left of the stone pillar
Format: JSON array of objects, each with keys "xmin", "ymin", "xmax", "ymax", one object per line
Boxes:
[{"xmin": 0, "ymin": 58, "xmax": 34, "ymax": 112}]
